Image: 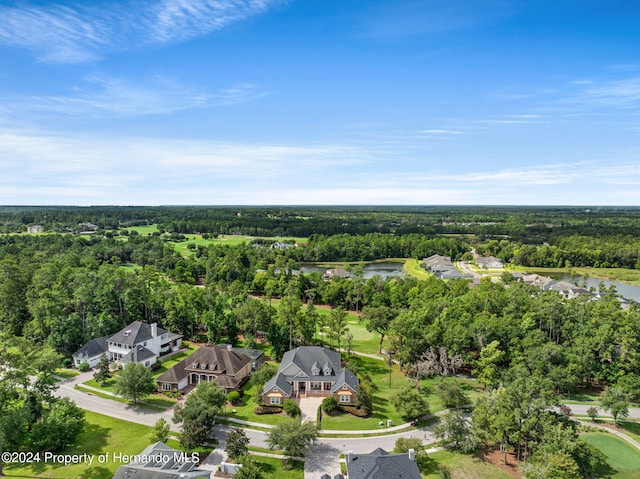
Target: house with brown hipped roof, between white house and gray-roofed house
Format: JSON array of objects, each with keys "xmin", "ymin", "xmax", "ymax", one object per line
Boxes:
[{"xmin": 157, "ymin": 344, "xmax": 253, "ymax": 393}]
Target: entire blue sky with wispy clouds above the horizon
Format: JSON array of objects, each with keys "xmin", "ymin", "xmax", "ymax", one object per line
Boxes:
[{"xmin": 0, "ymin": 0, "xmax": 640, "ymax": 205}]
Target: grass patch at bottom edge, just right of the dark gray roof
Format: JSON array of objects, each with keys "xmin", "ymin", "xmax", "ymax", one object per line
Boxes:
[{"xmin": 422, "ymin": 451, "xmax": 513, "ymax": 479}]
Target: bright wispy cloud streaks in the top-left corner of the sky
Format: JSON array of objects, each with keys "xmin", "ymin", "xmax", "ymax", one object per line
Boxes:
[{"xmin": 0, "ymin": 0, "xmax": 285, "ymax": 63}]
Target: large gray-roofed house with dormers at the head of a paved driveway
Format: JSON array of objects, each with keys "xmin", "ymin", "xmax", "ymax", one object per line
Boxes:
[{"xmin": 262, "ymin": 346, "xmax": 358, "ymax": 405}]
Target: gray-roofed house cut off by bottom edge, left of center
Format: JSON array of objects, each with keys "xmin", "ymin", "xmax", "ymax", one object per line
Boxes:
[{"xmin": 112, "ymin": 442, "xmax": 211, "ymax": 479}]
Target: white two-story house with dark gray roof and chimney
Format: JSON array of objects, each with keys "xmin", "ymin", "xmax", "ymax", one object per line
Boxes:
[{"xmin": 73, "ymin": 321, "xmax": 182, "ymax": 367}]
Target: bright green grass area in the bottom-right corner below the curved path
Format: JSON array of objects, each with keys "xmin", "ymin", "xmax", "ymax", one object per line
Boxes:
[{"xmin": 582, "ymin": 432, "xmax": 640, "ymax": 479}]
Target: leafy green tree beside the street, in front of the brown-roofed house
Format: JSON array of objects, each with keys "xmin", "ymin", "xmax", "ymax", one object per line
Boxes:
[{"xmin": 173, "ymin": 381, "xmax": 227, "ymax": 451}]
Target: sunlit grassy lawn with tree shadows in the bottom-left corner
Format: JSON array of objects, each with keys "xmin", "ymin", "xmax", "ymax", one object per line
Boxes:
[{"xmin": 4, "ymin": 411, "xmax": 185, "ymax": 479}]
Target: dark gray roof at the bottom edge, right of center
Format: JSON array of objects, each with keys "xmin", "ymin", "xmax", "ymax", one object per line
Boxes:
[{"xmin": 347, "ymin": 448, "xmax": 421, "ymax": 479}]
